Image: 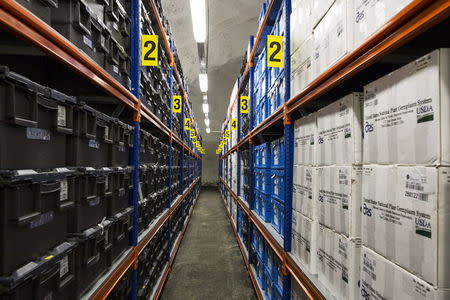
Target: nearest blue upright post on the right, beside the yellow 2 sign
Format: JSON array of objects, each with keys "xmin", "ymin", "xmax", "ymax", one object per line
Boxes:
[{"xmin": 282, "ymin": 0, "xmax": 294, "ymax": 300}]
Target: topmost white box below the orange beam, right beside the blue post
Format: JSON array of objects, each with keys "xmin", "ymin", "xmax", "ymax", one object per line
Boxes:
[{"xmin": 294, "ymin": 113, "xmax": 317, "ymax": 166}]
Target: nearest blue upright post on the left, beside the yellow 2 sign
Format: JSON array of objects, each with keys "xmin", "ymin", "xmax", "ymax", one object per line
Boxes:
[{"xmin": 129, "ymin": 0, "xmax": 141, "ymax": 300}]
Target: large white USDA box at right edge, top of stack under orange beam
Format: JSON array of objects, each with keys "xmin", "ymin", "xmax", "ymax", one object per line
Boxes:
[{"xmin": 363, "ymin": 49, "xmax": 450, "ymax": 166}]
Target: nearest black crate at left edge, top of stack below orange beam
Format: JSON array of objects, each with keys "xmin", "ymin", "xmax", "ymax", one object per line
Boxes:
[{"xmin": 0, "ymin": 66, "xmax": 76, "ymax": 169}]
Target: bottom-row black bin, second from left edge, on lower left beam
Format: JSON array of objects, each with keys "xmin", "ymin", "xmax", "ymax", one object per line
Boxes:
[{"xmin": 71, "ymin": 220, "xmax": 113, "ymax": 298}]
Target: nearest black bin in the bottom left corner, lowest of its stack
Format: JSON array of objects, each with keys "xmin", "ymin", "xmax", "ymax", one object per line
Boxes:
[{"xmin": 0, "ymin": 242, "xmax": 77, "ymax": 300}]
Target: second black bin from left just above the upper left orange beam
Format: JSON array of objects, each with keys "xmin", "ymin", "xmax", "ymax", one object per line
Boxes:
[{"xmin": 52, "ymin": 0, "xmax": 96, "ymax": 58}]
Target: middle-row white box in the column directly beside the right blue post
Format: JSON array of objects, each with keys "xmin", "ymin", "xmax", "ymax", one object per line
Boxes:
[{"xmin": 292, "ymin": 166, "xmax": 317, "ymax": 219}]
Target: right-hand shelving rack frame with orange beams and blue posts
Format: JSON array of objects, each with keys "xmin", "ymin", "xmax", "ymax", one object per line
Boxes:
[{"xmin": 219, "ymin": 0, "xmax": 450, "ymax": 299}]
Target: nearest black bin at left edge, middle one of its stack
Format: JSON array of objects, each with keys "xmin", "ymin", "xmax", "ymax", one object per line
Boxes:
[{"xmin": 0, "ymin": 169, "xmax": 76, "ymax": 276}]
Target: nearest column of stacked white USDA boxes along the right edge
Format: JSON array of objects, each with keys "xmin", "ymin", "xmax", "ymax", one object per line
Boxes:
[{"xmin": 361, "ymin": 49, "xmax": 450, "ymax": 299}]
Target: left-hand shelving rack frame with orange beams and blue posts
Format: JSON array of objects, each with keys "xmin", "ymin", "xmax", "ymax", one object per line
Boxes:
[{"xmin": 0, "ymin": 0, "xmax": 201, "ymax": 299}]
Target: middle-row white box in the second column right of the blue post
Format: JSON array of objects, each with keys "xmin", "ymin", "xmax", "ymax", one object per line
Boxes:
[{"xmin": 314, "ymin": 166, "xmax": 362, "ymax": 237}]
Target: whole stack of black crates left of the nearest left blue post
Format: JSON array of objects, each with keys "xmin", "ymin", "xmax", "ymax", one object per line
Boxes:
[{"xmin": 0, "ymin": 66, "xmax": 133, "ymax": 299}]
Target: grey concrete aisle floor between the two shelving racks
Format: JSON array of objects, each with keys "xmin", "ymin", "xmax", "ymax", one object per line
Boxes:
[{"xmin": 161, "ymin": 188, "xmax": 256, "ymax": 300}]
